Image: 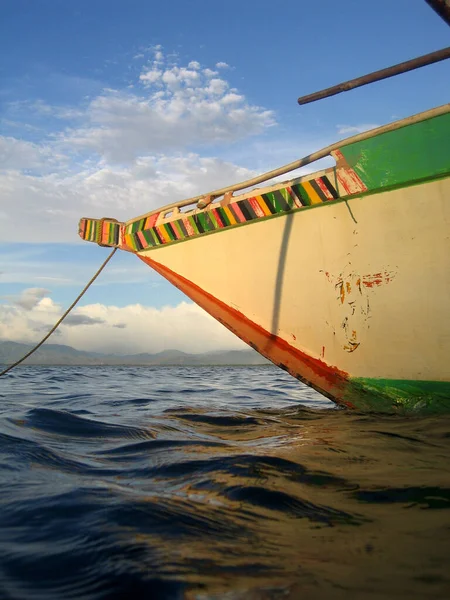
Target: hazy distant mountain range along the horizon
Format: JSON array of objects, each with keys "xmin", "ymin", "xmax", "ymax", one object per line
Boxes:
[{"xmin": 0, "ymin": 342, "xmax": 270, "ymax": 366}]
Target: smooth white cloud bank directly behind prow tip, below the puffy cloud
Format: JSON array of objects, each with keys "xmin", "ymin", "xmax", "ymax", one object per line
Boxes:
[{"xmin": 0, "ymin": 153, "xmax": 253, "ymax": 243}]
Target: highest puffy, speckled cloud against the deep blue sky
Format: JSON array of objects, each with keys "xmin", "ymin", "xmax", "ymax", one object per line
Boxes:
[{"xmin": 59, "ymin": 50, "xmax": 275, "ymax": 163}]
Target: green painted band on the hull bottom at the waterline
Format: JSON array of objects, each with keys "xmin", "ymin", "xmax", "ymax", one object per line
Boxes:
[{"xmin": 345, "ymin": 377, "xmax": 450, "ymax": 413}]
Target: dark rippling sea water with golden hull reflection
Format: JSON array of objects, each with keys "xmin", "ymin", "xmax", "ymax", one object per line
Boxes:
[{"xmin": 0, "ymin": 367, "xmax": 450, "ymax": 600}]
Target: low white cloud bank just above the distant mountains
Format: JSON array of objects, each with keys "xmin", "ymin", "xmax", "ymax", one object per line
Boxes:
[{"xmin": 0, "ymin": 290, "xmax": 246, "ymax": 354}]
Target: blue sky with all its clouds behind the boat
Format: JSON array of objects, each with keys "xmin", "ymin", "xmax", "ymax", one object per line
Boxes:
[{"xmin": 0, "ymin": 0, "xmax": 450, "ymax": 353}]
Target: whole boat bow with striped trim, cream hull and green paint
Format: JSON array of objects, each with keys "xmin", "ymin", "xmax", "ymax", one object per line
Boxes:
[{"xmin": 79, "ymin": 3, "xmax": 450, "ymax": 412}]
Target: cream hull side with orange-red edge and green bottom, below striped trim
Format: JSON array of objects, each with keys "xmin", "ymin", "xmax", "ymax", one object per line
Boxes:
[{"xmin": 138, "ymin": 177, "xmax": 450, "ymax": 410}]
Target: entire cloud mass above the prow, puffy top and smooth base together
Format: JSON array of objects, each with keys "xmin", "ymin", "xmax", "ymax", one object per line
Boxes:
[{"xmin": 0, "ymin": 46, "xmax": 274, "ymax": 242}]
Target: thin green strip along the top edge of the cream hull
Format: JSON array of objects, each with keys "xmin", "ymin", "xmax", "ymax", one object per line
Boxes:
[{"xmin": 143, "ymin": 174, "xmax": 448, "ymax": 252}]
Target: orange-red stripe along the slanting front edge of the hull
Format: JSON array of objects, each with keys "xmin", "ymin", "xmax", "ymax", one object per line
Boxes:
[{"xmin": 137, "ymin": 254, "xmax": 352, "ymax": 407}]
